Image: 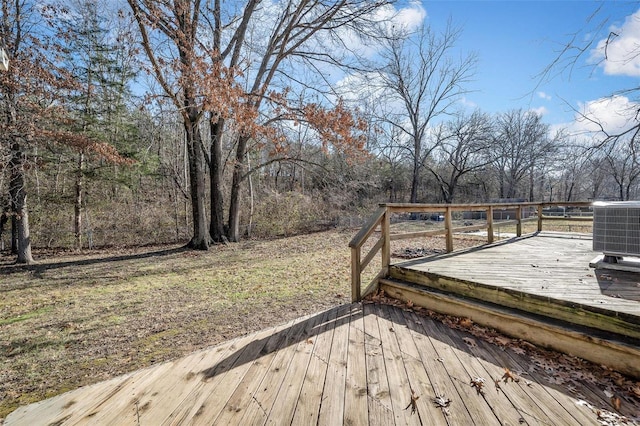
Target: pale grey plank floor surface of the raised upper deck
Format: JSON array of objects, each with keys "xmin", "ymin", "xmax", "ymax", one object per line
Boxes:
[{"xmin": 390, "ymin": 232, "xmax": 640, "ymax": 320}]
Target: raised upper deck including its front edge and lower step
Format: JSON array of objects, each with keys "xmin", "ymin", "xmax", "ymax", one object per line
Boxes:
[{"xmin": 381, "ymin": 233, "xmax": 640, "ymax": 377}]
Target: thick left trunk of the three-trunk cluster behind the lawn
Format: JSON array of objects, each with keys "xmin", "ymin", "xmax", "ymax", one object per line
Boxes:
[{"xmin": 184, "ymin": 119, "xmax": 210, "ymax": 250}]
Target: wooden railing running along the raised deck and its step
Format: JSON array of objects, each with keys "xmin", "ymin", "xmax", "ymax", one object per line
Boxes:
[{"xmin": 349, "ymin": 201, "xmax": 593, "ymax": 301}]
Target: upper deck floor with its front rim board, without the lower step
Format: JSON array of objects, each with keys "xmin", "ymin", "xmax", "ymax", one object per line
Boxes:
[{"xmin": 390, "ymin": 234, "xmax": 640, "ymax": 338}]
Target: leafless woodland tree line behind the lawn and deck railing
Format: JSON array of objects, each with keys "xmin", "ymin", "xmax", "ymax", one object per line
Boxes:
[{"xmin": 0, "ymin": 0, "xmax": 640, "ymax": 263}]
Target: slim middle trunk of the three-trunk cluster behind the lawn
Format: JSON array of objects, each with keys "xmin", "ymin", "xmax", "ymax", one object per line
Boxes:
[{"xmin": 209, "ymin": 116, "xmax": 227, "ymax": 243}]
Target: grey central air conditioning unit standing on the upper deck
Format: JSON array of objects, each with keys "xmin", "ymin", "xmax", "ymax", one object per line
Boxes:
[{"xmin": 593, "ymin": 201, "xmax": 640, "ymax": 263}]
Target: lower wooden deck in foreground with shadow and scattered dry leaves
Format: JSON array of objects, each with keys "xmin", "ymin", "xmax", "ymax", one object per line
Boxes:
[{"xmin": 4, "ymin": 303, "xmax": 640, "ymax": 426}]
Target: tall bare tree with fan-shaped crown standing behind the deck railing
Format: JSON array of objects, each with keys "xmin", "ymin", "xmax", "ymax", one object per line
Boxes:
[{"xmin": 379, "ymin": 23, "xmax": 477, "ymax": 203}]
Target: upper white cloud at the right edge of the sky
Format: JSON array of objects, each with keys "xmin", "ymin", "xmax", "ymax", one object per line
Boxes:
[{"xmin": 590, "ymin": 10, "xmax": 640, "ymax": 77}]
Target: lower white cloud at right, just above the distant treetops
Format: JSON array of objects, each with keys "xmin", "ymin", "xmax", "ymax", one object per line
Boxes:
[{"xmin": 567, "ymin": 96, "xmax": 640, "ymax": 135}]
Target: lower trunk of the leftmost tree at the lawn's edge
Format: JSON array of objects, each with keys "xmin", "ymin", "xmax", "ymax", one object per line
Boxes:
[{"xmin": 9, "ymin": 141, "xmax": 33, "ymax": 263}]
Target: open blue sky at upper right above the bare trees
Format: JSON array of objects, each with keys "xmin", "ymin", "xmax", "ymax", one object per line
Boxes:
[{"xmin": 413, "ymin": 0, "xmax": 640, "ymax": 132}]
